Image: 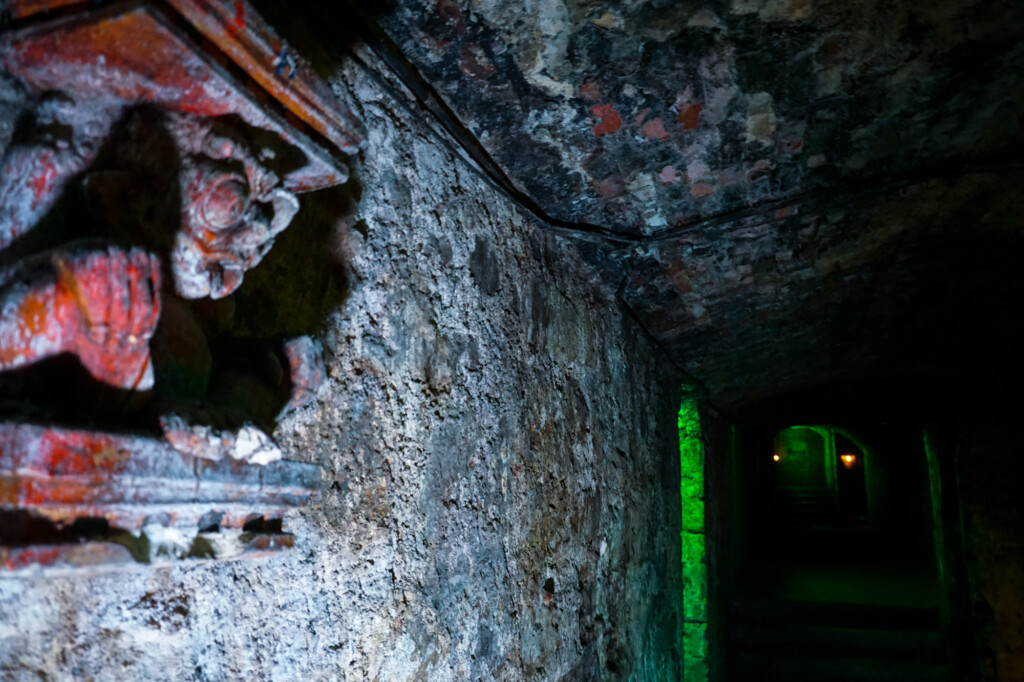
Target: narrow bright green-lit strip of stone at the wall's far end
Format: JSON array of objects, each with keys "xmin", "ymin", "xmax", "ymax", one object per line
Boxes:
[{"xmin": 679, "ymin": 397, "xmax": 708, "ymax": 682}]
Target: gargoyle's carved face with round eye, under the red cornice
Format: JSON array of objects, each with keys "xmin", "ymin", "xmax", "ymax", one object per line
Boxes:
[{"xmin": 171, "ymin": 132, "xmax": 299, "ymax": 299}]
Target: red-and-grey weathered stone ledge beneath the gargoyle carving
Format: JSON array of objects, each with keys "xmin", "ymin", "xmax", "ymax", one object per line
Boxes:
[{"xmin": 0, "ymin": 424, "xmax": 319, "ymax": 528}]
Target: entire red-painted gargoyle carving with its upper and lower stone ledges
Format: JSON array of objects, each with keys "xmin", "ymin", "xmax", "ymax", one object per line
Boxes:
[{"xmin": 0, "ymin": 0, "xmax": 346, "ymax": 570}]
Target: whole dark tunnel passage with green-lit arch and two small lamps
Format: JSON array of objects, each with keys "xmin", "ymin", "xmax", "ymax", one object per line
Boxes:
[{"xmin": 710, "ymin": 384, "xmax": 963, "ymax": 682}]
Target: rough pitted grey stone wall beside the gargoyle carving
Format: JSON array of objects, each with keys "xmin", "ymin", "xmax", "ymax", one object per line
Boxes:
[{"xmin": 0, "ymin": 49, "xmax": 681, "ymax": 682}]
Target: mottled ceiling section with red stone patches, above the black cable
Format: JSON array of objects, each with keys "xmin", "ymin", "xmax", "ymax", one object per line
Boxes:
[{"xmin": 380, "ymin": 0, "xmax": 1024, "ymax": 233}]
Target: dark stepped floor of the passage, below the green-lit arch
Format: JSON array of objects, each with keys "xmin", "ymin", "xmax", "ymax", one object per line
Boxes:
[{"xmin": 726, "ymin": 529, "xmax": 951, "ymax": 682}]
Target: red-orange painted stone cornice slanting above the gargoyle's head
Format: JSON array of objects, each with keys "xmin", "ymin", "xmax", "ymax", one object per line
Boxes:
[{"xmin": 0, "ymin": 0, "xmax": 361, "ymax": 190}]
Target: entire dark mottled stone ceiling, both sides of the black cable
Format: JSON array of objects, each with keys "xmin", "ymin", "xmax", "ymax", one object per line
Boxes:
[{"xmin": 286, "ymin": 0, "xmax": 1024, "ymax": 404}]
